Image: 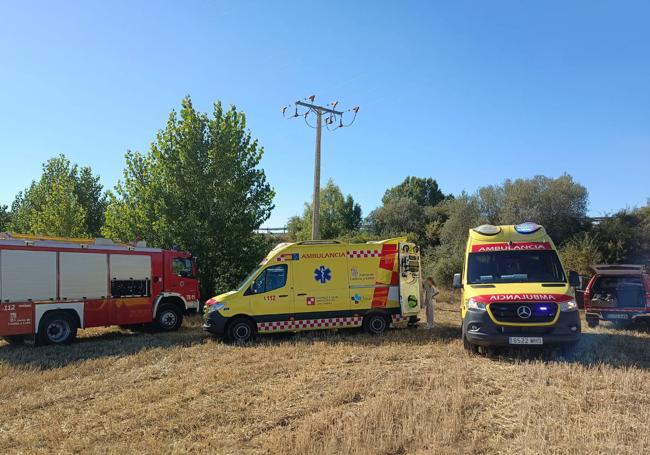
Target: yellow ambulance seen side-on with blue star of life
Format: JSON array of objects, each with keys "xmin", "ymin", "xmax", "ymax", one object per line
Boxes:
[{"xmin": 203, "ymin": 238, "xmax": 421, "ymax": 342}]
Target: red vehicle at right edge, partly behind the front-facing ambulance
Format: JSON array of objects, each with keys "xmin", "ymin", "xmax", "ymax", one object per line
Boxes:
[{"xmin": 584, "ymin": 265, "xmax": 650, "ymax": 327}]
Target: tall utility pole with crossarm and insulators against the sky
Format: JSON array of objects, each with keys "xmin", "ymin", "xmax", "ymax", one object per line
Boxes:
[{"xmin": 282, "ymin": 95, "xmax": 359, "ymax": 240}]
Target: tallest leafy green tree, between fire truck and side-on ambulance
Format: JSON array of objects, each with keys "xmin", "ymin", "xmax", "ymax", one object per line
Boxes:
[{"xmin": 103, "ymin": 96, "xmax": 274, "ymax": 296}]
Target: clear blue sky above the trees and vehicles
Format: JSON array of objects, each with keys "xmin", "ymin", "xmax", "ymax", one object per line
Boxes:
[{"xmin": 0, "ymin": 0, "xmax": 650, "ymax": 226}]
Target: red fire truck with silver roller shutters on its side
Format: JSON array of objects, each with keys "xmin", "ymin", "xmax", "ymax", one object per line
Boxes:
[{"xmin": 0, "ymin": 234, "xmax": 199, "ymax": 344}]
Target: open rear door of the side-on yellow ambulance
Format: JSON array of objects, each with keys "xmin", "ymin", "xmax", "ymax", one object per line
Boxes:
[{"xmin": 398, "ymin": 242, "xmax": 422, "ymax": 316}]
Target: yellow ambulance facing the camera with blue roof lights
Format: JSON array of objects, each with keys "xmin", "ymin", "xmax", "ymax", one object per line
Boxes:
[{"xmin": 454, "ymin": 222, "xmax": 580, "ymax": 352}]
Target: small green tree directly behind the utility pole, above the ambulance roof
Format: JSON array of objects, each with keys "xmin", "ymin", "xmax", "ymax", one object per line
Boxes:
[{"xmin": 287, "ymin": 179, "xmax": 362, "ymax": 240}]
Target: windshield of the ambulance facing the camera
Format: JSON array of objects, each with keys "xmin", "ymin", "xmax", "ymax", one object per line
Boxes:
[{"xmin": 467, "ymin": 250, "xmax": 566, "ymax": 284}]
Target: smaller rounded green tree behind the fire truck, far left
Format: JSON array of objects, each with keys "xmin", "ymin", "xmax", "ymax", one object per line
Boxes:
[{"xmin": 9, "ymin": 155, "xmax": 106, "ymax": 237}]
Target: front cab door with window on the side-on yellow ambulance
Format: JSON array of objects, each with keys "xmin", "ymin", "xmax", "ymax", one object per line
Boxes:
[{"xmin": 245, "ymin": 264, "xmax": 294, "ymax": 322}]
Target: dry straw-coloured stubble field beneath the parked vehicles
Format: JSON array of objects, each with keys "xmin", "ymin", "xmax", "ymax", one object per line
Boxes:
[{"xmin": 0, "ymin": 305, "xmax": 650, "ymax": 454}]
